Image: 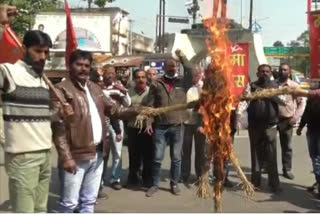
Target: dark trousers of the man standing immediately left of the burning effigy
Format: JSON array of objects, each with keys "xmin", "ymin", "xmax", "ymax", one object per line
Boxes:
[{"xmin": 181, "ymin": 124, "xmax": 206, "ymax": 182}]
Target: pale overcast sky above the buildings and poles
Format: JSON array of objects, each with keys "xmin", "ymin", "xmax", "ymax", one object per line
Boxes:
[{"xmin": 69, "ymin": 0, "xmax": 307, "ymax": 46}]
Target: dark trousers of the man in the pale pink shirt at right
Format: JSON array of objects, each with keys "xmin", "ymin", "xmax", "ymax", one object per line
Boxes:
[{"xmin": 278, "ymin": 119, "xmax": 293, "ymax": 172}]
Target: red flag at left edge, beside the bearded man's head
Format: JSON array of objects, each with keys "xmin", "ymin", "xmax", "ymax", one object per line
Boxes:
[{"xmin": 0, "ymin": 25, "xmax": 23, "ymax": 64}]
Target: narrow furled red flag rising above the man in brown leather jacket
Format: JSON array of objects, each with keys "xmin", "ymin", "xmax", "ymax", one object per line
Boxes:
[{"xmin": 64, "ymin": 0, "xmax": 78, "ymax": 67}]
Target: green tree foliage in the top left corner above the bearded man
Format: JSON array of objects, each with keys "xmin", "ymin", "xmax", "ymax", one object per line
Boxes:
[{"xmin": 0, "ymin": 0, "xmax": 57, "ymax": 37}]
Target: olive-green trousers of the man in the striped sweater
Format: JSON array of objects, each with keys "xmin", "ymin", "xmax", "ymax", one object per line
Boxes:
[{"xmin": 5, "ymin": 150, "xmax": 51, "ymax": 213}]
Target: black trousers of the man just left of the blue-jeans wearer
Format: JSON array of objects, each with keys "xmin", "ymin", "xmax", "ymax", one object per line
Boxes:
[{"xmin": 127, "ymin": 127, "xmax": 153, "ymax": 185}]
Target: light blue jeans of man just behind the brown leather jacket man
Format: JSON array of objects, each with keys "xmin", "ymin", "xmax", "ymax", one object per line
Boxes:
[{"xmin": 108, "ymin": 120, "xmax": 124, "ymax": 183}]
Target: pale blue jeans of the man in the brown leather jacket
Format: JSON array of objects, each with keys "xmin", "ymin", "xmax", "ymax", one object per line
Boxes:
[{"xmin": 59, "ymin": 152, "xmax": 103, "ymax": 213}]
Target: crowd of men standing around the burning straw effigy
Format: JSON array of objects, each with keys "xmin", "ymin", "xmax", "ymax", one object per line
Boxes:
[{"xmin": 0, "ymin": 5, "xmax": 320, "ymax": 213}]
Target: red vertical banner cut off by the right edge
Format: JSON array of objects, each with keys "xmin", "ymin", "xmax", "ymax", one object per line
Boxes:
[{"xmin": 309, "ymin": 11, "xmax": 320, "ymax": 78}]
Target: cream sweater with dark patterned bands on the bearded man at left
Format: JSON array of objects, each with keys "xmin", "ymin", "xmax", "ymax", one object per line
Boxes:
[{"xmin": 0, "ymin": 60, "xmax": 52, "ymax": 153}]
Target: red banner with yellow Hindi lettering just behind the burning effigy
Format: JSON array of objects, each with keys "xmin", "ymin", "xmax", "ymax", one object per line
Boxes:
[{"xmin": 231, "ymin": 43, "xmax": 249, "ymax": 96}]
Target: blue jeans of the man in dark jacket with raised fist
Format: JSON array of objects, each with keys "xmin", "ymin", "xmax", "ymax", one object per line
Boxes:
[{"xmin": 152, "ymin": 124, "xmax": 183, "ymax": 186}]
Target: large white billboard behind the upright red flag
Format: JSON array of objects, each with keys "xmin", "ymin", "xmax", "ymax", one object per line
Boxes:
[{"xmin": 33, "ymin": 13, "xmax": 111, "ymax": 52}]
